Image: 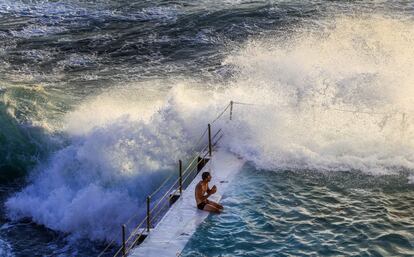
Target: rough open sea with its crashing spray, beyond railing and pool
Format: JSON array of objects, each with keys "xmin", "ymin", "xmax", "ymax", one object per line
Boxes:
[{"xmin": 0, "ymin": 1, "xmax": 414, "ymax": 255}]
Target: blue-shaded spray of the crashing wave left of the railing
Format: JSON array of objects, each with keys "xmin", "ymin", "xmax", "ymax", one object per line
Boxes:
[{"xmin": 6, "ymin": 91, "xmax": 192, "ymax": 240}]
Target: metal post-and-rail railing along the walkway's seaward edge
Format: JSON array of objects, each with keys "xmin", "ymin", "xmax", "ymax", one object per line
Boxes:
[{"xmin": 98, "ymin": 101, "xmax": 233, "ymax": 257}]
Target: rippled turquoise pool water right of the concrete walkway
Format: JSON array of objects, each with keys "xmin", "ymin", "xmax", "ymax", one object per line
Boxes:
[{"xmin": 182, "ymin": 165, "xmax": 414, "ymax": 257}]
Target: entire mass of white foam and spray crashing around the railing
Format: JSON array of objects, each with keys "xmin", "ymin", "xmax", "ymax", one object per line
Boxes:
[{"xmin": 6, "ymin": 17, "xmax": 414, "ymax": 239}]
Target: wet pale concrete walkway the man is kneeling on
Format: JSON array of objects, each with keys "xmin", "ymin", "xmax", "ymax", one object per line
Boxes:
[{"xmin": 129, "ymin": 150, "xmax": 245, "ymax": 257}]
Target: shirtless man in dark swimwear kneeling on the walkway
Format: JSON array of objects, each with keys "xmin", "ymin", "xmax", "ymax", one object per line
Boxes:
[{"xmin": 195, "ymin": 172, "xmax": 223, "ymax": 213}]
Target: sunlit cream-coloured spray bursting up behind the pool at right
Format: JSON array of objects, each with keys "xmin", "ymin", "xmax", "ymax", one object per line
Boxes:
[{"xmin": 217, "ymin": 16, "xmax": 414, "ymax": 174}]
